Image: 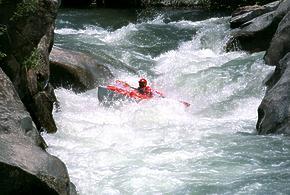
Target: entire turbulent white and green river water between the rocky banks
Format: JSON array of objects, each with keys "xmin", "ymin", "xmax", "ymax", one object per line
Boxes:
[{"xmin": 44, "ymin": 9, "xmax": 290, "ymax": 194}]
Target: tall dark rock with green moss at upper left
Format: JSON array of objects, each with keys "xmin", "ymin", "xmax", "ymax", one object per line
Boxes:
[{"xmin": 0, "ymin": 0, "xmax": 58, "ymax": 132}]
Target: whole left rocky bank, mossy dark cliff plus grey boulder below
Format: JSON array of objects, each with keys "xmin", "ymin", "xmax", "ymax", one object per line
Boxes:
[{"xmin": 0, "ymin": 0, "xmax": 76, "ymax": 194}]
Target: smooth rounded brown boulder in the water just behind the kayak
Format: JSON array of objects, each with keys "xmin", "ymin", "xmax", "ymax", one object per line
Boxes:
[{"xmin": 50, "ymin": 47, "xmax": 113, "ymax": 92}]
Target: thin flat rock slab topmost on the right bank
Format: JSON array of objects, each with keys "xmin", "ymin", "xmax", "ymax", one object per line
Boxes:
[{"xmin": 230, "ymin": 1, "xmax": 280, "ymax": 28}]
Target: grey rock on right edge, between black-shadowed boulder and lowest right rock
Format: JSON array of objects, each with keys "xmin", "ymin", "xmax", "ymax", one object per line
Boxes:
[{"xmin": 264, "ymin": 12, "xmax": 290, "ymax": 65}]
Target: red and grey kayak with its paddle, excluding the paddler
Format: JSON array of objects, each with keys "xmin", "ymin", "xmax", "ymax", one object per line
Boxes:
[{"xmin": 98, "ymin": 80, "xmax": 190, "ymax": 107}]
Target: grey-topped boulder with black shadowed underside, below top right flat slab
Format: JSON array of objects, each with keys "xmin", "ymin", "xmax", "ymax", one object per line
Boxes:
[{"xmin": 226, "ymin": 0, "xmax": 290, "ymax": 52}]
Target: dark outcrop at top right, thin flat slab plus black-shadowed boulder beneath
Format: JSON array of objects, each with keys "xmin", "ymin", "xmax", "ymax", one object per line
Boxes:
[{"xmin": 227, "ymin": 0, "xmax": 290, "ymax": 52}]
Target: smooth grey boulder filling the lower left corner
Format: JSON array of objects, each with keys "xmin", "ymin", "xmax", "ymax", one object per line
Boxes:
[{"xmin": 0, "ymin": 68, "xmax": 75, "ymax": 194}]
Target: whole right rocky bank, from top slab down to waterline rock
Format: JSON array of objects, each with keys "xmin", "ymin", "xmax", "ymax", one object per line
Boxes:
[{"xmin": 228, "ymin": 0, "xmax": 290, "ymax": 134}]
